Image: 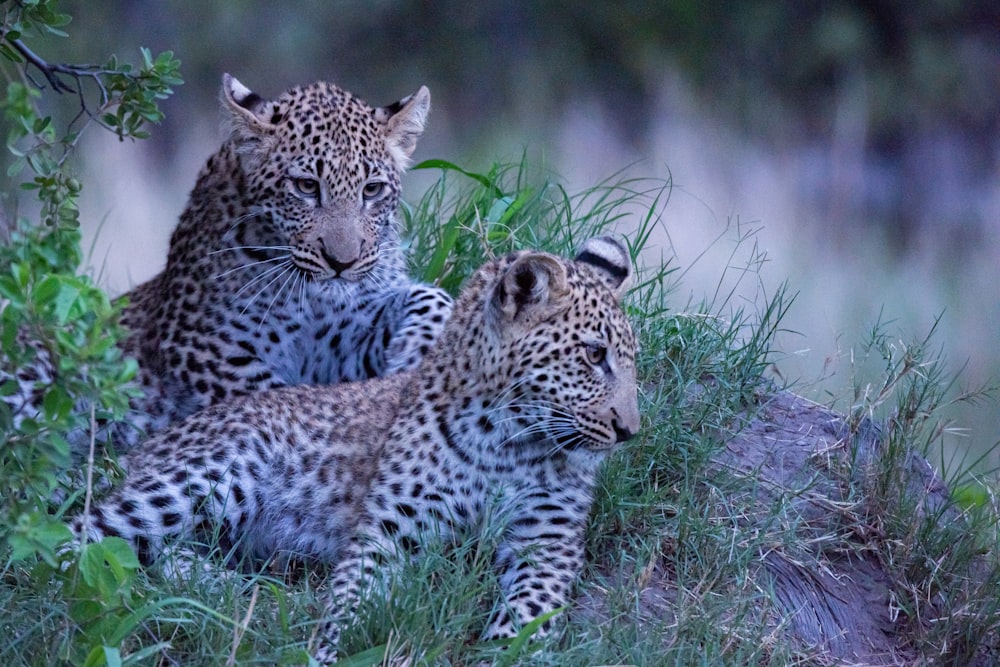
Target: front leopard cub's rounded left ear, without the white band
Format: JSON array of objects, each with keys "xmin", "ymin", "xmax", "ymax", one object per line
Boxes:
[{"xmin": 493, "ymin": 253, "xmax": 569, "ymax": 325}]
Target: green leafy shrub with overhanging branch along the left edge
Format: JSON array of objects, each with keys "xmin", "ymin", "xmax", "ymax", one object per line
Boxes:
[{"xmin": 0, "ymin": 0, "xmax": 181, "ymax": 576}]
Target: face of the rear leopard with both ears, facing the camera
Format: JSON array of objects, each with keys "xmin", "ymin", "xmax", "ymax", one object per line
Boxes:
[{"xmin": 223, "ymin": 75, "xmax": 430, "ymax": 281}]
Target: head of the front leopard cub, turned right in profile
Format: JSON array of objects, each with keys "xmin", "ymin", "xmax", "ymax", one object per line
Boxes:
[{"xmin": 456, "ymin": 239, "xmax": 639, "ymax": 464}]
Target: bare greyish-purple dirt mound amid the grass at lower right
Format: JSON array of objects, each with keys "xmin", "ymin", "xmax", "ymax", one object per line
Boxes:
[{"xmin": 583, "ymin": 391, "xmax": 992, "ymax": 666}]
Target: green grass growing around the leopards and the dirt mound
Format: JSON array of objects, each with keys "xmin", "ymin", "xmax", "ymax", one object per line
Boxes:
[{"xmin": 0, "ymin": 161, "xmax": 1000, "ymax": 666}]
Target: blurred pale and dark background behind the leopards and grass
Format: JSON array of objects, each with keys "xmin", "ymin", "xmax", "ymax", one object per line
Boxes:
[{"xmin": 23, "ymin": 5, "xmax": 1000, "ymax": 470}]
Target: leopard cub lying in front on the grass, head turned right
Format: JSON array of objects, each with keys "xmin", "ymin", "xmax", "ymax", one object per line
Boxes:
[{"xmin": 71, "ymin": 236, "xmax": 640, "ymax": 664}]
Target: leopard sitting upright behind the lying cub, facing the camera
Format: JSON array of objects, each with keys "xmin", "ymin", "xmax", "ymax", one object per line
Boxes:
[{"xmin": 0, "ymin": 74, "xmax": 453, "ymax": 451}]
